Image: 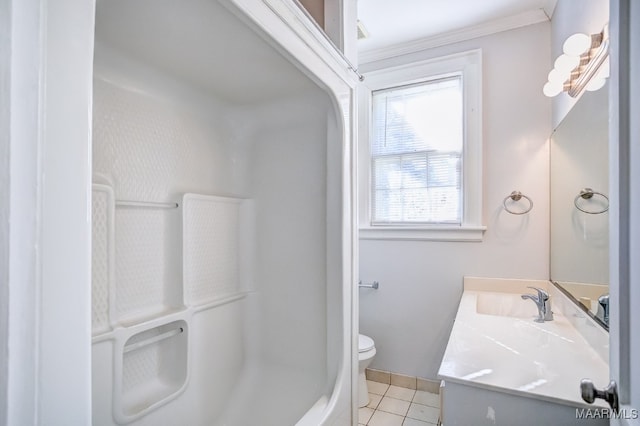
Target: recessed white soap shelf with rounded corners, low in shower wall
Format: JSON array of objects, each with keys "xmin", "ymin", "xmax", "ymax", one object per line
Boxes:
[{"xmin": 113, "ymin": 319, "xmax": 189, "ymax": 424}]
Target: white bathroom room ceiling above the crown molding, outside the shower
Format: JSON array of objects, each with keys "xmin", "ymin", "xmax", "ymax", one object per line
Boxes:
[{"xmin": 358, "ymin": 0, "xmax": 557, "ymax": 54}]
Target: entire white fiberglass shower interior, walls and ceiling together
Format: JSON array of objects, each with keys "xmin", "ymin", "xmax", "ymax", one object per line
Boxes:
[{"xmin": 92, "ymin": 0, "xmax": 345, "ymax": 426}]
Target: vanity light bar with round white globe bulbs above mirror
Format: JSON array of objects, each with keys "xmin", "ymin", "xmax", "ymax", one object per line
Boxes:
[{"xmin": 542, "ymin": 25, "xmax": 609, "ymax": 98}]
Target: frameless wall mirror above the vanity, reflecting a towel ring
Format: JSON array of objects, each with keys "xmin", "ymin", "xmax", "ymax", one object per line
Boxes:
[{"xmin": 550, "ymin": 84, "xmax": 609, "ymax": 329}]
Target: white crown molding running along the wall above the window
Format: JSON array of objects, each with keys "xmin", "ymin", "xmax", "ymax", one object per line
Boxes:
[{"xmin": 358, "ymin": 9, "xmax": 549, "ymax": 65}]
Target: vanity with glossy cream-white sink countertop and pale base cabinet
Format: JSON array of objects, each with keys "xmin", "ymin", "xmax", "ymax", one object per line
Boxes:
[{"xmin": 438, "ymin": 277, "xmax": 609, "ymax": 426}]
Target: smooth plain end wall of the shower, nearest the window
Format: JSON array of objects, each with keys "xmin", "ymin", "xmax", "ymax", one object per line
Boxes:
[{"xmin": 251, "ymin": 121, "xmax": 327, "ymax": 372}]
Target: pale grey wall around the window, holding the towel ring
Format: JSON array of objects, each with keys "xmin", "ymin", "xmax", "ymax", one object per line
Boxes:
[{"xmin": 360, "ymin": 23, "xmax": 551, "ymax": 378}]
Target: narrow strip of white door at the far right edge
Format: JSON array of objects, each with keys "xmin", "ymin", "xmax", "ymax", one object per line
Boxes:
[{"xmin": 609, "ymin": 0, "xmax": 640, "ymax": 426}]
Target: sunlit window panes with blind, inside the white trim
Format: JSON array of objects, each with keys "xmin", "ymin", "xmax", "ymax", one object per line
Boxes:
[{"xmin": 371, "ymin": 75, "xmax": 464, "ymax": 224}]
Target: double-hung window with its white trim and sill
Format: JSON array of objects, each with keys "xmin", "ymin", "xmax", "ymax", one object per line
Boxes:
[{"xmin": 359, "ymin": 51, "xmax": 485, "ymax": 241}]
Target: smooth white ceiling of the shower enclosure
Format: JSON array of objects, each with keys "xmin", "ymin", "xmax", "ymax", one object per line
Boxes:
[{"xmin": 96, "ymin": 0, "xmax": 317, "ymax": 105}]
